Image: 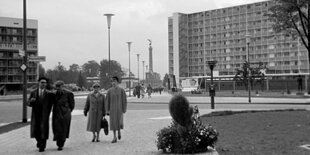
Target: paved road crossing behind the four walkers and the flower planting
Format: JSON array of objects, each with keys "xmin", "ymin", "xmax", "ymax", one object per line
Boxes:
[{"xmin": 0, "ymin": 94, "xmax": 310, "ymax": 126}]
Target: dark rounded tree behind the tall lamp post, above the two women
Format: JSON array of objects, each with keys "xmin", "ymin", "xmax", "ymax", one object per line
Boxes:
[{"xmin": 100, "ymin": 59, "xmax": 125, "ymax": 89}]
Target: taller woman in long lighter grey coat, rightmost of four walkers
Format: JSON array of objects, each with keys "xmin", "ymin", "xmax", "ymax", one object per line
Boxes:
[{"xmin": 106, "ymin": 76, "xmax": 127, "ymax": 143}]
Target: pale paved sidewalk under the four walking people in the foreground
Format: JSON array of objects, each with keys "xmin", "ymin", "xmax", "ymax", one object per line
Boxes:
[{"xmin": 0, "ymin": 109, "xmax": 217, "ymax": 155}]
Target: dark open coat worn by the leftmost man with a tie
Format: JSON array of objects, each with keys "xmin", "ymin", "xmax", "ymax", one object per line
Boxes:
[{"xmin": 27, "ymin": 89, "xmax": 53, "ymax": 139}]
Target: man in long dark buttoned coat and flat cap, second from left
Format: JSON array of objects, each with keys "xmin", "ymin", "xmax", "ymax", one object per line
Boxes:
[{"xmin": 52, "ymin": 81, "xmax": 75, "ymax": 151}]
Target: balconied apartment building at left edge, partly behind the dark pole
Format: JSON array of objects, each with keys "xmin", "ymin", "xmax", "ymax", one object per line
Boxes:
[{"xmin": 0, "ymin": 17, "xmax": 38, "ymax": 90}]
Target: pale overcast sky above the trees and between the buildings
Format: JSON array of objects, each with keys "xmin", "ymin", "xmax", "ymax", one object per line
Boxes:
[{"xmin": 0, "ymin": 0, "xmax": 264, "ymax": 78}]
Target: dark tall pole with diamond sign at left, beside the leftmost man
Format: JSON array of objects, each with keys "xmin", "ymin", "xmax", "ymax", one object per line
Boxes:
[{"xmin": 22, "ymin": 0, "xmax": 28, "ymax": 123}]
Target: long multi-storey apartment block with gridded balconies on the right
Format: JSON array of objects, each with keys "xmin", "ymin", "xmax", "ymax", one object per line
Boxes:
[{"xmin": 168, "ymin": 1, "xmax": 309, "ymax": 85}]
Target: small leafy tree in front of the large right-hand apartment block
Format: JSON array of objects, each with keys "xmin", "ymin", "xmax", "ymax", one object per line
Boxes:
[{"xmin": 234, "ymin": 61, "xmax": 267, "ymax": 90}]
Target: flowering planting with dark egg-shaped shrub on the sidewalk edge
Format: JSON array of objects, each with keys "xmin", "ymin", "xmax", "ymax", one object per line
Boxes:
[{"xmin": 156, "ymin": 95, "xmax": 219, "ymax": 153}]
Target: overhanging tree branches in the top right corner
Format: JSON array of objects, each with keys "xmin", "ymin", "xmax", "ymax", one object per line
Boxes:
[{"xmin": 265, "ymin": 0, "xmax": 310, "ymax": 67}]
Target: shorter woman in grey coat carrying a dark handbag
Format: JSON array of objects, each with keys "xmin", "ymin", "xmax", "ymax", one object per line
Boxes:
[{"xmin": 84, "ymin": 83, "xmax": 105, "ymax": 142}]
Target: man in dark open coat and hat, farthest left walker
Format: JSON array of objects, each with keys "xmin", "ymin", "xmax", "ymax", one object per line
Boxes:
[{"xmin": 27, "ymin": 77, "xmax": 53, "ymax": 152}]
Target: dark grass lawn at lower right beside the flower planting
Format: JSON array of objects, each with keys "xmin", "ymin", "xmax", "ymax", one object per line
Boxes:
[{"xmin": 202, "ymin": 110, "xmax": 310, "ymax": 155}]
